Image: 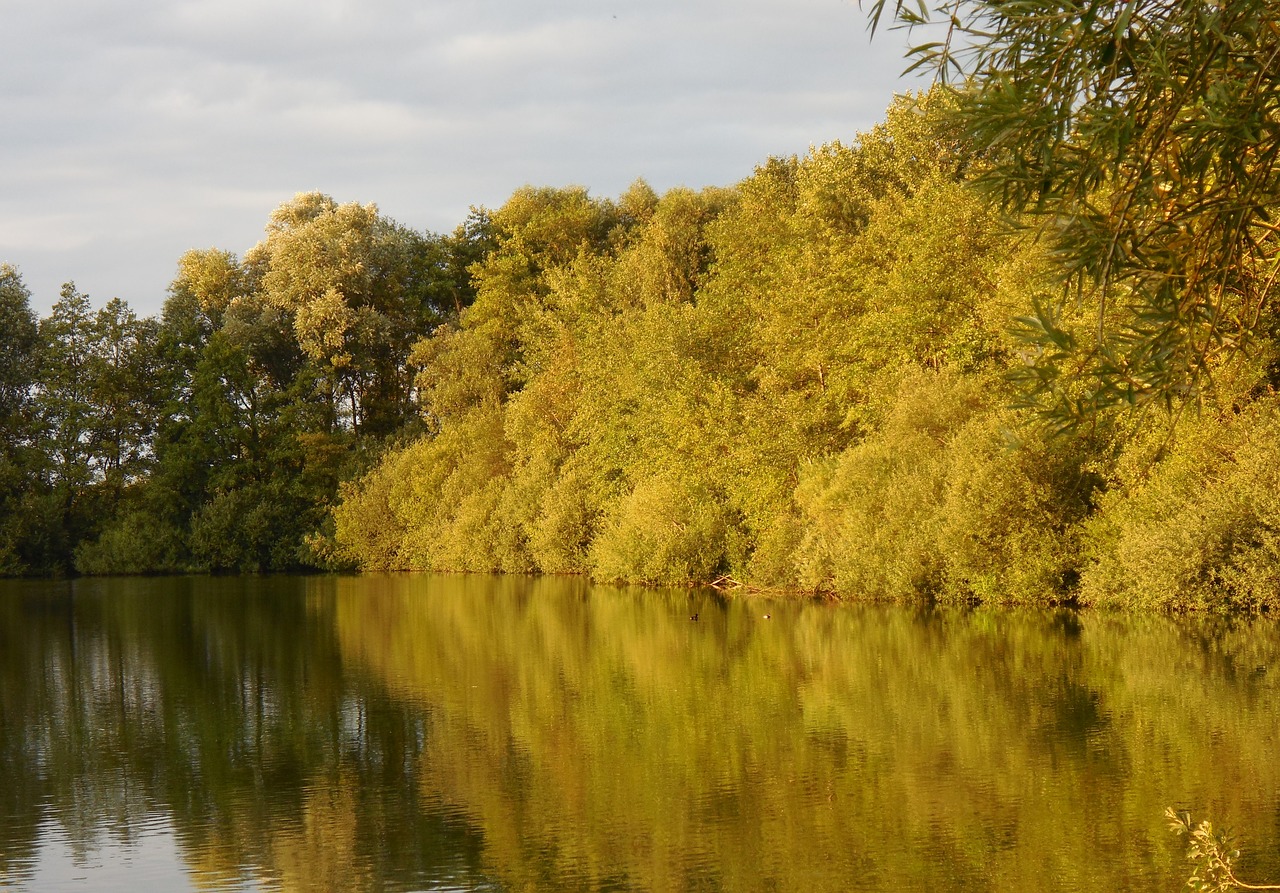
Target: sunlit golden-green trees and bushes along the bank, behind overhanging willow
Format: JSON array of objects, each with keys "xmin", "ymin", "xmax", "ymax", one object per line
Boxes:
[{"xmin": 325, "ymin": 91, "xmax": 1280, "ymax": 609}]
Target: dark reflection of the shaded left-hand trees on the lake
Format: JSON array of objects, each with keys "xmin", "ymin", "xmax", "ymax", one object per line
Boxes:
[{"xmin": 0, "ymin": 578, "xmax": 484, "ymax": 889}]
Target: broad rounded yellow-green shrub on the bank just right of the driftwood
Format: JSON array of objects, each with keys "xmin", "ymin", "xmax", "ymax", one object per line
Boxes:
[{"xmin": 796, "ymin": 372, "xmax": 1098, "ymax": 603}]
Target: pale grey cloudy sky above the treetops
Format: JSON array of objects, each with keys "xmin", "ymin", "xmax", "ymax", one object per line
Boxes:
[{"xmin": 0, "ymin": 0, "xmax": 920, "ymax": 315}]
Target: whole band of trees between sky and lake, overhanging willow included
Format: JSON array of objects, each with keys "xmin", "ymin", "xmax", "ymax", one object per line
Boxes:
[{"xmin": 0, "ymin": 0, "xmax": 1280, "ymax": 610}]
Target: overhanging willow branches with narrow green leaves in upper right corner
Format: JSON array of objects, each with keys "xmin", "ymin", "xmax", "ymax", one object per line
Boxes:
[{"xmin": 869, "ymin": 0, "xmax": 1280, "ymax": 426}]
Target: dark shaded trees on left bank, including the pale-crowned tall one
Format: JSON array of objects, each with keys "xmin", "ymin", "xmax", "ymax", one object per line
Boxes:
[{"xmin": 0, "ymin": 193, "xmax": 486, "ymax": 574}]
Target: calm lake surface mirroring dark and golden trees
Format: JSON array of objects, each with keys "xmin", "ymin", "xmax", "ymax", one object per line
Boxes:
[{"xmin": 0, "ymin": 576, "xmax": 1280, "ymax": 893}]
